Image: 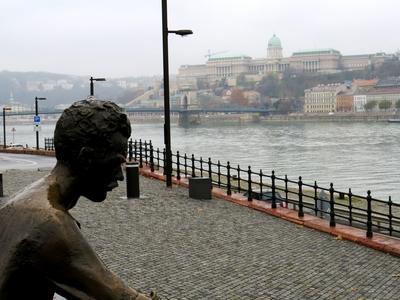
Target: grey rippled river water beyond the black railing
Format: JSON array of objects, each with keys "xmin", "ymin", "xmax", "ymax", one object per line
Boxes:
[{"xmin": 3, "ymin": 122, "xmax": 400, "ymax": 202}]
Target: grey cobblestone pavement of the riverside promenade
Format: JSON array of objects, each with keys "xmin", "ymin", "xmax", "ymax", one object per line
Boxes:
[{"xmin": 3, "ymin": 171, "xmax": 400, "ymax": 300}]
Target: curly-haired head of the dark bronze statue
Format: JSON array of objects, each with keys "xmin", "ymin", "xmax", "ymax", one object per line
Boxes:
[{"xmin": 54, "ymin": 100, "xmax": 131, "ymax": 201}]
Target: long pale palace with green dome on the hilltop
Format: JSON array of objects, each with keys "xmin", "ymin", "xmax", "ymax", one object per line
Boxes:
[{"xmin": 177, "ymin": 34, "xmax": 395, "ymax": 89}]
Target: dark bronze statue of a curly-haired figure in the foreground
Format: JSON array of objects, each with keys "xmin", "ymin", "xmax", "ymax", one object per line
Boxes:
[{"xmin": 0, "ymin": 100, "xmax": 157, "ymax": 300}]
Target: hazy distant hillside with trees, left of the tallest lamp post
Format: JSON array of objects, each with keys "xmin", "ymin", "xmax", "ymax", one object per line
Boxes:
[{"xmin": 0, "ymin": 71, "xmax": 160, "ymax": 108}]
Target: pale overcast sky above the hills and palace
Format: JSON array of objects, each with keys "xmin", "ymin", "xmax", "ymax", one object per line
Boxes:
[{"xmin": 0, "ymin": 0, "xmax": 400, "ymax": 77}]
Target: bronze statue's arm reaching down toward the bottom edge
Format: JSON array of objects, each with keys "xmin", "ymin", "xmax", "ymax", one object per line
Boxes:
[{"xmin": 32, "ymin": 221, "xmax": 150, "ymax": 300}]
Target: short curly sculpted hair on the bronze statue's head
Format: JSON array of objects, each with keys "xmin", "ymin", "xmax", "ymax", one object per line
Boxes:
[{"xmin": 54, "ymin": 100, "xmax": 131, "ymax": 163}]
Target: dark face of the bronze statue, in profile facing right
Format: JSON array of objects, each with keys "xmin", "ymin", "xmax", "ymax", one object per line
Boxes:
[{"xmin": 81, "ymin": 132, "xmax": 128, "ymax": 202}]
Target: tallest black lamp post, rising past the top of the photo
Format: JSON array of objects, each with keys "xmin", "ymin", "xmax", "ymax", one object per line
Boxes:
[{"xmin": 161, "ymin": 0, "xmax": 193, "ymax": 187}]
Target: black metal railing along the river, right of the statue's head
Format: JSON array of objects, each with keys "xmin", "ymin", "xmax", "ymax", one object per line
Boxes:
[{"xmin": 128, "ymin": 140, "xmax": 400, "ymax": 237}]
